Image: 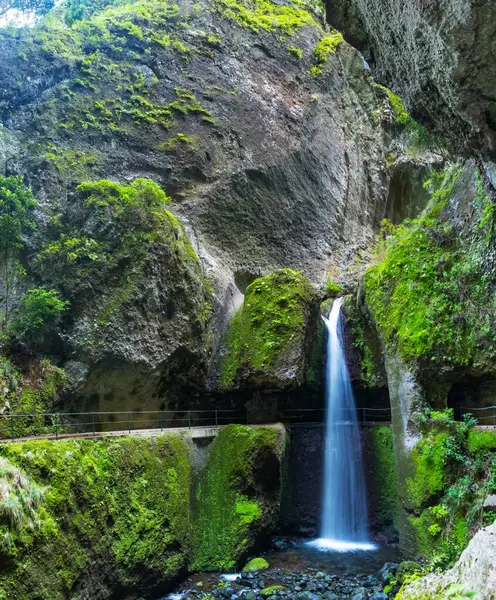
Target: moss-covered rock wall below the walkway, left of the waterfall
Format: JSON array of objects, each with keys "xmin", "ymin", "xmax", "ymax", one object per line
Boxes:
[{"xmin": 0, "ymin": 425, "xmax": 285, "ymax": 600}]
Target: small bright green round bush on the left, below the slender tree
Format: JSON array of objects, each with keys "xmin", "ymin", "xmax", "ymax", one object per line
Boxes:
[{"xmin": 12, "ymin": 287, "xmax": 70, "ymax": 338}]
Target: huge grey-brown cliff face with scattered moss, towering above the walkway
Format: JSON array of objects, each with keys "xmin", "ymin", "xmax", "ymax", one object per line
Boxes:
[{"xmin": 0, "ymin": 0, "xmax": 434, "ymax": 410}]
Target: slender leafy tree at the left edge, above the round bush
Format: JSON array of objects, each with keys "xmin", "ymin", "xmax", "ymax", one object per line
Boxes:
[{"xmin": 0, "ymin": 177, "xmax": 36, "ymax": 327}]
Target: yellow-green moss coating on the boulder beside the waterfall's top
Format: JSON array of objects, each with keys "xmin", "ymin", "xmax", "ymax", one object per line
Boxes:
[{"xmin": 221, "ymin": 269, "xmax": 315, "ymax": 386}]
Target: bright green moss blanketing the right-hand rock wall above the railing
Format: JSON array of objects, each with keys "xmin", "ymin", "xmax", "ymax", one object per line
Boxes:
[{"xmin": 365, "ymin": 167, "xmax": 495, "ymax": 365}]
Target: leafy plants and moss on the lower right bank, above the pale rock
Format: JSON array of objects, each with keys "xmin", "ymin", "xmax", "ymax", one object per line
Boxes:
[{"xmin": 407, "ymin": 410, "xmax": 496, "ymax": 568}]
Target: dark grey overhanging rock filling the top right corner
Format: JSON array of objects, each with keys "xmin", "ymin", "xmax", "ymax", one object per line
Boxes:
[{"xmin": 326, "ymin": 0, "xmax": 496, "ymax": 159}]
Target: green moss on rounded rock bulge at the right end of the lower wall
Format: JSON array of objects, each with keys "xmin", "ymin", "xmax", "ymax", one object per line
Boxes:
[{"xmin": 191, "ymin": 425, "xmax": 279, "ymax": 571}]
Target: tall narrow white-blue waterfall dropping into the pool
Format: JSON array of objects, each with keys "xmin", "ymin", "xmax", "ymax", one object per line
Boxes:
[{"xmin": 310, "ymin": 298, "xmax": 375, "ymax": 552}]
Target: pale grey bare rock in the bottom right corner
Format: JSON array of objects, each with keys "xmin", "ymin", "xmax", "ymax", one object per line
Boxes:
[{"xmin": 396, "ymin": 523, "xmax": 496, "ymax": 600}]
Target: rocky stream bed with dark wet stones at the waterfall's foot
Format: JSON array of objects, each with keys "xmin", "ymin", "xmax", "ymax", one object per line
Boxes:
[{"xmin": 164, "ymin": 541, "xmax": 399, "ymax": 600}]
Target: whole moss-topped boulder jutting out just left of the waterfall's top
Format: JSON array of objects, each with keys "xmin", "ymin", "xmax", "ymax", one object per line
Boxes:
[{"xmin": 221, "ymin": 269, "xmax": 318, "ymax": 388}]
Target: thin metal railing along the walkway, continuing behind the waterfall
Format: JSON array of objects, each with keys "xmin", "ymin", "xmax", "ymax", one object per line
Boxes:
[{"xmin": 0, "ymin": 408, "xmax": 391, "ymax": 441}]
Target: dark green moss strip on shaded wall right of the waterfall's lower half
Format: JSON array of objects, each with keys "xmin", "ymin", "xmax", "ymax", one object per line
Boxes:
[{"xmin": 367, "ymin": 426, "xmax": 399, "ymax": 527}]
